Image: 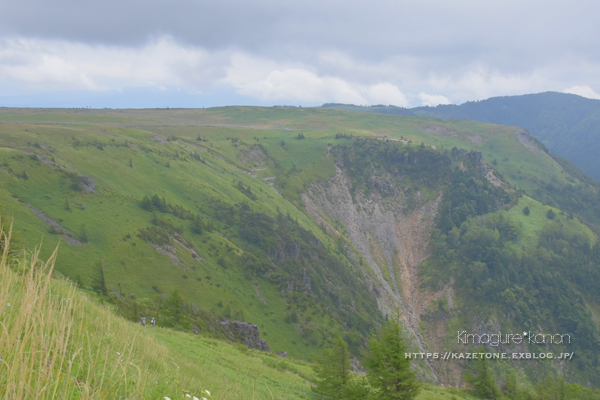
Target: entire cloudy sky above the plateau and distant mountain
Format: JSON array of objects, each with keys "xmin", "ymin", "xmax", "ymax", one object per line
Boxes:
[{"xmin": 0, "ymin": 0, "xmax": 600, "ymax": 107}]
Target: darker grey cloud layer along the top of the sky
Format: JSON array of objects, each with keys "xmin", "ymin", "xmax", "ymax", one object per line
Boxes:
[{"xmin": 0, "ymin": 0, "xmax": 600, "ymax": 68}]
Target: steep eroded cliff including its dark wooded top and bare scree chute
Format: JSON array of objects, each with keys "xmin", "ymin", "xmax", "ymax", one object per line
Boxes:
[{"xmin": 302, "ymin": 141, "xmax": 508, "ymax": 386}]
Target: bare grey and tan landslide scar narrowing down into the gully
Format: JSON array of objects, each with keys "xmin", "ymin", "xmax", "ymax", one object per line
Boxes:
[{"xmin": 302, "ymin": 161, "xmax": 442, "ymax": 381}]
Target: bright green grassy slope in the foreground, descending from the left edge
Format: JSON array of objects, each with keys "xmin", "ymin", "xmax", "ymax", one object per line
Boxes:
[{"xmin": 0, "ymin": 223, "xmax": 482, "ymax": 400}]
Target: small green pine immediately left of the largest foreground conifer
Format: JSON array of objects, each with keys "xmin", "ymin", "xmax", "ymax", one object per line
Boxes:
[{"xmin": 313, "ymin": 336, "xmax": 350, "ymax": 400}]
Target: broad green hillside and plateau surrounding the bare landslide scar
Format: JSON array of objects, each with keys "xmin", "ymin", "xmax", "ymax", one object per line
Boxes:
[{"xmin": 0, "ymin": 107, "xmax": 600, "ymax": 390}]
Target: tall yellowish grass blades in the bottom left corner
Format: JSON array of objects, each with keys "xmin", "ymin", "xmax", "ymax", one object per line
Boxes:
[{"xmin": 0, "ymin": 222, "xmax": 166, "ymax": 399}]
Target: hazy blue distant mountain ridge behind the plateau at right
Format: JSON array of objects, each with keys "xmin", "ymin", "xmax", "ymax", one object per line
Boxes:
[{"xmin": 323, "ymin": 92, "xmax": 600, "ymax": 180}]
